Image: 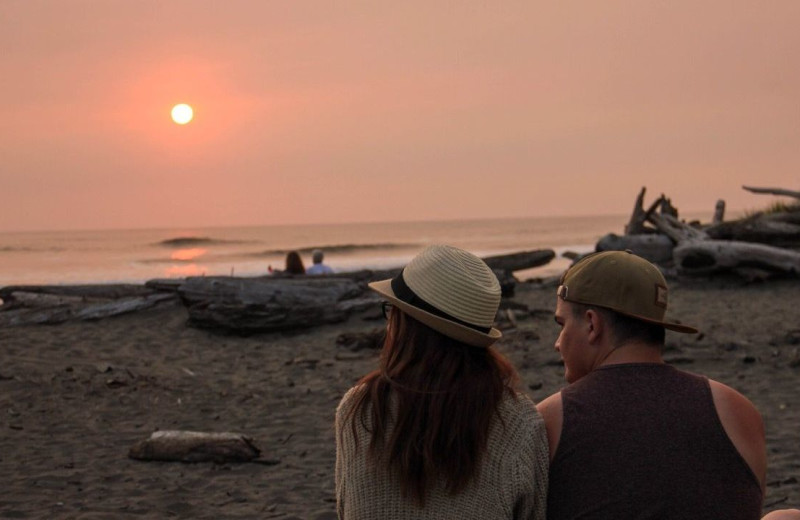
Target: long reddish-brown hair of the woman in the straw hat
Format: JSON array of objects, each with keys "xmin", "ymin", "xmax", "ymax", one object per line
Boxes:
[{"xmin": 348, "ymin": 308, "xmax": 518, "ymax": 505}]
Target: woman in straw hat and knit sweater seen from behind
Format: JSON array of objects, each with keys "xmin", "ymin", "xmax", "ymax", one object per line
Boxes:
[{"xmin": 336, "ymin": 246, "xmax": 548, "ymax": 520}]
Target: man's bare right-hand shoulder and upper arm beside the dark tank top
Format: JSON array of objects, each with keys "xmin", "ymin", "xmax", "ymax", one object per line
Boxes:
[{"xmin": 708, "ymin": 379, "xmax": 767, "ymax": 491}]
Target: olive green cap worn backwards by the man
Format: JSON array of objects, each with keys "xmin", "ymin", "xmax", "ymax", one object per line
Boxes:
[{"xmin": 558, "ymin": 251, "xmax": 697, "ymax": 334}]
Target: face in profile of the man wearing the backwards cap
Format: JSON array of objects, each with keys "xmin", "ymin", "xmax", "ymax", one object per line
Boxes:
[{"xmin": 555, "ymin": 298, "xmax": 594, "ymax": 383}]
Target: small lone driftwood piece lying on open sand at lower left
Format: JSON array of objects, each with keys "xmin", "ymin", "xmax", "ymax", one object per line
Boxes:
[{"xmin": 128, "ymin": 430, "xmax": 261, "ymax": 463}]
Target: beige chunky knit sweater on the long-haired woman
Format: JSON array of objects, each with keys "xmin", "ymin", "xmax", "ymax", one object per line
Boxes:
[{"xmin": 336, "ymin": 387, "xmax": 549, "ymax": 520}]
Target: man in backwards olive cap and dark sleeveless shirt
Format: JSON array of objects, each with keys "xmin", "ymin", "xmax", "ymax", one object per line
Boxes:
[{"xmin": 538, "ymin": 251, "xmax": 766, "ymax": 520}]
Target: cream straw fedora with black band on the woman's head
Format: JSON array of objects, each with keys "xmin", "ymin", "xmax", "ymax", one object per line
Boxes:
[{"xmin": 369, "ymin": 245, "xmax": 503, "ymax": 347}]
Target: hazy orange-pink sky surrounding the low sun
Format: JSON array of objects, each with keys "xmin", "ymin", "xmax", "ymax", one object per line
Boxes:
[{"xmin": 0, "ymin": 0, "xmax": 800, "ymax": 230}]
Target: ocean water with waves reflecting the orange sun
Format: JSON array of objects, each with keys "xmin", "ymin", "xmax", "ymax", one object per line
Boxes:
[{"xmin": 0, "ymin": 215, "xmax": 628, "ymax": 287}]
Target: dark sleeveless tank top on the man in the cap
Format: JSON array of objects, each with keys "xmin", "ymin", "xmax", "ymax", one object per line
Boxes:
[{"xmin": 547, "ymin": 364, "xmax": 763, "ymax": 520}]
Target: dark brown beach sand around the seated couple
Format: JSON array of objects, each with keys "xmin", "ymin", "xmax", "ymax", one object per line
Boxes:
[{"xmin": 0, "ymin": 280, "xmax": 800, "ymax": 519}]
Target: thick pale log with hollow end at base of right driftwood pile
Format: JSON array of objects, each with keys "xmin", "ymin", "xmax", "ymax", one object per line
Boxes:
[{"xmin": 674, "ymin": 240, "xmax": 800, "ymax": 276}]
